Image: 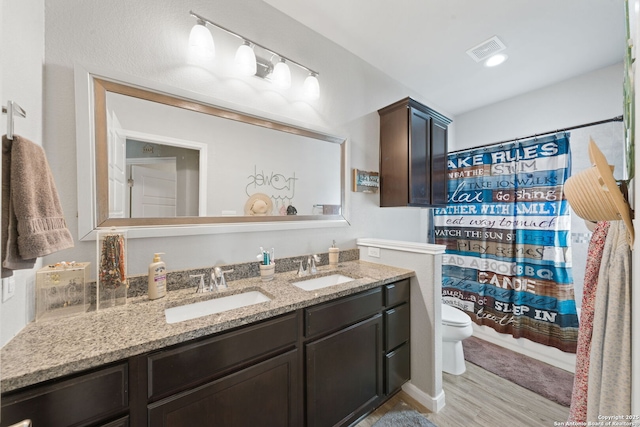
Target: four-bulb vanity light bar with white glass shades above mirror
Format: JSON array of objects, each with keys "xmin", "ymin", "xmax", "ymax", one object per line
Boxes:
[{"xmin": 189, "ymin": 11, "xmax": 320, "ymax": 99}]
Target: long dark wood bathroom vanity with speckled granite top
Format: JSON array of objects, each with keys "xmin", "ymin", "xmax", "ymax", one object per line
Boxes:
[{"xmin": 1, "ymin": 261, "xmax": 413, "ymax": 427}]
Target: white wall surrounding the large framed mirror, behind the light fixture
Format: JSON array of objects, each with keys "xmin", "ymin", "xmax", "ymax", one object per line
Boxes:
[{"xmin": 45, "ymin": 0, "xmax": 446, "ymax": 280}]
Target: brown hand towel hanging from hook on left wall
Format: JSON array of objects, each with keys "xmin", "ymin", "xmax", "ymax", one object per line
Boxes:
[{"xmin": 2, "ymin": 135, "xmax": 73, "ymax": 277}]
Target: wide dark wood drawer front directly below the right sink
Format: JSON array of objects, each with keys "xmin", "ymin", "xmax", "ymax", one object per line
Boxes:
[{"xmin": 304, "ymin": 288, "xmax": 382, "ymax": 338}]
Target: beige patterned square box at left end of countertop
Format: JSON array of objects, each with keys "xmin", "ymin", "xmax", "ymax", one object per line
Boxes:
[{"xmin": 36, "ymin": 262, "xmax": 91, "ymax": 321}]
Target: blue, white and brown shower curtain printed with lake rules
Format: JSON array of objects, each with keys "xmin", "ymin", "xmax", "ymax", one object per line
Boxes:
[{"xmin": 434, "ymin": 133, "xmax": 578, "ymax": 353}]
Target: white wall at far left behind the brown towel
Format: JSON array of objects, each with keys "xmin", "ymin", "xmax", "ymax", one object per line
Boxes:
[{"xmin": 0, "ymin": 0, "xmax": 44, "ymax": 345}]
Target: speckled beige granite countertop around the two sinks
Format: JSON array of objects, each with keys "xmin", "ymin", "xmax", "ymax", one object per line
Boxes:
[{"xmin": 0, "ymin": 261, "xmax": 414, "ymax": 393}]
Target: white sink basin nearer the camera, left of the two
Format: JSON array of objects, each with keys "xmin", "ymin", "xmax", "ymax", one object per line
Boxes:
[{"xmin": 164, "ymin": 291, "xmax": 271, "ymax": 323}]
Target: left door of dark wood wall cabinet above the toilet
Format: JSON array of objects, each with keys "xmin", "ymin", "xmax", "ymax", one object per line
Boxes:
[{"xmin": 409, "ymin": 108, "xmax": 431, "ymax": 206}]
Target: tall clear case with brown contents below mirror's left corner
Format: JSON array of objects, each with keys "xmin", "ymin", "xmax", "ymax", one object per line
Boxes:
[{"xmin": 96, "ymin": 229, "xmax": 129, "ymax": 310}]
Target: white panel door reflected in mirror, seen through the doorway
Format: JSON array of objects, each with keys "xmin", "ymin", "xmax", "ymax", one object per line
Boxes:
[{"xmin": 131, "ymin": 163, "xmax": 177, "ymax": 218}]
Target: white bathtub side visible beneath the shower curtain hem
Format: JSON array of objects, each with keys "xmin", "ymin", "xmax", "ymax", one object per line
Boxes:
[{"xmin": 473, "ymin": 324, "xmax": 576, "ymax": 373}]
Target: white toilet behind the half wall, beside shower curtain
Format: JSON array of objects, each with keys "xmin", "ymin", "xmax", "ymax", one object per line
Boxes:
[{"xmin": 442, "ymin": 304, "xmax": 473, "ymax": 375}]
